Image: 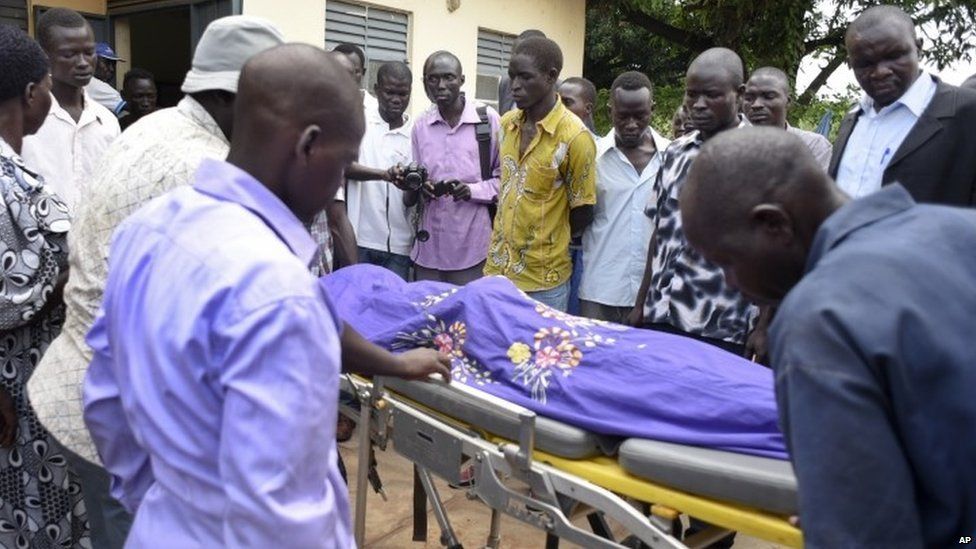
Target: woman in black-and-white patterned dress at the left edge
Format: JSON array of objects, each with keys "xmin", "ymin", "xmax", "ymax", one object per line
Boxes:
[{"xmin": 0, "ymin": 25, "xmax": 91, "ymax": 549}]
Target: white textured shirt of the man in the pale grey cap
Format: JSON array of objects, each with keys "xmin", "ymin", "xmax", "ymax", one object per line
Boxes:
[{"xmin": 27, "ymin": 96, "xmax": 230, "ymax": 463}]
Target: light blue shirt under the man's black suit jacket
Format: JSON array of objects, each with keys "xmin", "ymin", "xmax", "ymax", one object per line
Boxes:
[{"xmin": 837, "ymin": 73, "xmax": 935, "ymax": 198}]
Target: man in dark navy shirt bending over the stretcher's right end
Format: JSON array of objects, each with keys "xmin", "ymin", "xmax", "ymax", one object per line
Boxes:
[{"xmin": 681, "ymin": 128, "xmax": 976, "ymax": 549}]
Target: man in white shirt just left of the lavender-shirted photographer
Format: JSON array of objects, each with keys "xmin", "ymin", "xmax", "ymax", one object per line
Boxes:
[{"xmin": 346, "ymin": 62, "xmax": 414, "ymax": 280}]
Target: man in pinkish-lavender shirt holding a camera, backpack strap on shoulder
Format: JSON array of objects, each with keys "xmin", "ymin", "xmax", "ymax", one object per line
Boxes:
[{"xmin": 404, "ymin": 51, "xmax": 501, "ymax": 285}]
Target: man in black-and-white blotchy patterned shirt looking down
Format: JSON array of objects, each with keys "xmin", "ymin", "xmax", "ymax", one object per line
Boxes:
[{"xmin": 628, "ymin": 48, "xmax": 757, "ymax": 355}]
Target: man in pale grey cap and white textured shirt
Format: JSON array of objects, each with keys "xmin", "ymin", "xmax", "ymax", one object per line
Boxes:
[{"xmin": 28, "ymin": 16, "xmax": 284, "ymax": 548}]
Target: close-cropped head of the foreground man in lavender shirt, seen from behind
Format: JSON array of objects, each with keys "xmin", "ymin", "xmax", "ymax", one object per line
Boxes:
[{"xmin": 228, "ymin": 44, "xmax": 365, "ymax": 221}]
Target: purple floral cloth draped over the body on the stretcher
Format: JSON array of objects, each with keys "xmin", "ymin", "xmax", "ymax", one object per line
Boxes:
[{"xmin": 321, "ymin": 265, "xmax": 787, "ymax": 459}]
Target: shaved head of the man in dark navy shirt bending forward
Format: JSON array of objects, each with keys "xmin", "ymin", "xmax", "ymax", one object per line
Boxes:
[{"xmin": 679, "ymin": 127, "xmax": 843, "ymax": 303}]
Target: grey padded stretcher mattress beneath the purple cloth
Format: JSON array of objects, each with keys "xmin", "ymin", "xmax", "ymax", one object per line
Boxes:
[{"xmin": 384, "ymin": 378, "xmax": 797, "ymax": 515}]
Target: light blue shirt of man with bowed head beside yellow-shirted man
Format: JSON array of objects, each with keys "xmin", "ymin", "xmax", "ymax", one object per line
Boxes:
[{"xmin": 579, "ymin": 128, "xmax": 670, "ymax": 307}]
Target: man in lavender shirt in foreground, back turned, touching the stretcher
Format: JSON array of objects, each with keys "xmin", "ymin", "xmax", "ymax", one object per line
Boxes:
[{"xmin": 84, "ymin": 44, "xmax": 447, "ymax": 548}]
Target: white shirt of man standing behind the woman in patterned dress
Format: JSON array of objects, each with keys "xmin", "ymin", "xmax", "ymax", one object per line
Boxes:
[{"xmin": 21, "ymin": 94, "xmax": 121, "ymax": 213}]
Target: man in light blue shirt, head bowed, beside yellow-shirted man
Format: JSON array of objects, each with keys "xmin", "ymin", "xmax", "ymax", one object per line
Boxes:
[{"xmin": 580, "ymin": 71, "xmax": 670, "ymax": 324}]
